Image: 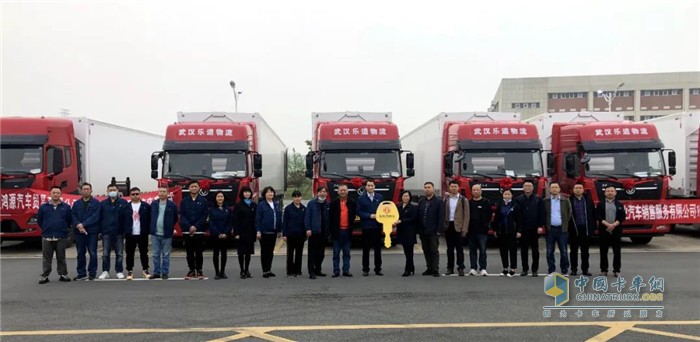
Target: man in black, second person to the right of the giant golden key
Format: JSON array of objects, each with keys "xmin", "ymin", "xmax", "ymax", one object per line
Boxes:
[{"xmin": 418, "ymin": 182, "xmax": 445, "ymax": 277}]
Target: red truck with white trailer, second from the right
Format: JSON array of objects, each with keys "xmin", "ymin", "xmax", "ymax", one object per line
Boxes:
[{"xmin": 401, "ymin": 112, "xmax": 547, "ymax": 201}]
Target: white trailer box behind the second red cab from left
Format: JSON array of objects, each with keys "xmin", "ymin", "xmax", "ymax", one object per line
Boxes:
[{"xmin": 176, "ymin": 112, "xmax": 287, "ymax": 194}]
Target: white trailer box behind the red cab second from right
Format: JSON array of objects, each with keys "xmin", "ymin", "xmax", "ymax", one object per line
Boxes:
[{"xmin": 401, "ymin": 112, "xmax": 520, "ymax": 195}]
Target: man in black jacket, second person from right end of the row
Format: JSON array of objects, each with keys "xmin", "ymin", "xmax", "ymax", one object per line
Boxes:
[{"xmin": 569, "ymin": 182, "xmax": 596, "ymax": 277}]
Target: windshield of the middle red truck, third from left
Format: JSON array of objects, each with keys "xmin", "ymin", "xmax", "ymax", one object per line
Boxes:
[{"xmin": 321, "ymin": 151, "xmax": 401, "ymax": 177}]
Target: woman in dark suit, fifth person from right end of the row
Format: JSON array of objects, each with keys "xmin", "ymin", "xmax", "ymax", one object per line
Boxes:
[{"xmin": 493, "ymin": 189, "xmax": 520, "ymax": 277}]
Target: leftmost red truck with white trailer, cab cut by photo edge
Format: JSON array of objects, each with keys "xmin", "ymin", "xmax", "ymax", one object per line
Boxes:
[{"xmin": 0, "ymin": 117, "xmax": 163, "ymax": 240}]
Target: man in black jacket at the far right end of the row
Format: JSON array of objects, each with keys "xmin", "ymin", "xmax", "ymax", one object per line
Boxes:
[{"xmin": 596, "ymin": 185, "xmax": 627, "ymax": 277}]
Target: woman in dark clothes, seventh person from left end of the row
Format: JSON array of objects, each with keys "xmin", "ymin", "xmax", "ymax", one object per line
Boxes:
[{"xmin": 209, "ymin": 191, "xmax": 232, "ymax": 280}]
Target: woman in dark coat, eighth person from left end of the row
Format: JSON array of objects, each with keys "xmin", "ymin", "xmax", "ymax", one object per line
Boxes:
[{"xmin": 233, "ymin": 187, "xmax": 257, "ymax": 279}]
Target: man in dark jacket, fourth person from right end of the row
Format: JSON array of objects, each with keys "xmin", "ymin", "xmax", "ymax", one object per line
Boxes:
[{"xmin": 515, "ymin": 181, "xmax": 546, "ymax": 277}]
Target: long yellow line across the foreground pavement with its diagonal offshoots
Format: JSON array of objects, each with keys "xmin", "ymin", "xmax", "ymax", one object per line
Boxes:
[{"xmin": 0, "ymin": 320, "xmax": 700, "ymax": 342}]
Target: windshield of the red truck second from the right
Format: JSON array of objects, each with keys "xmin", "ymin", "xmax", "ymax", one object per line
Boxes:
[{"xmin": 458, "ymin": 151, "xmax": 543, "ymax": 177}]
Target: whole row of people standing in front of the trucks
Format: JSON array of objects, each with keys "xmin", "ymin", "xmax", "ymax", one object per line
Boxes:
[{"xmin": 37, "ymin": 180, "xmax": 626, "ymax": 284}]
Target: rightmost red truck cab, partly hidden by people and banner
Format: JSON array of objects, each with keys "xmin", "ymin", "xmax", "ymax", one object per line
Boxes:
[{"xmin": 547, "ymin": 121, "xmax": 676, "ymax": 244}]
